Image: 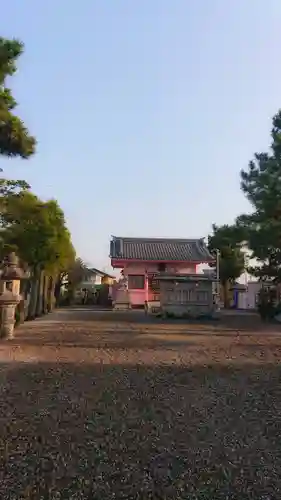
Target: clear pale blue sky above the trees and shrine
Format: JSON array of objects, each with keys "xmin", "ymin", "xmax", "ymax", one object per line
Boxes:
[{"xmin": 1, "ymin": 0, "xmax": 281, "ymax": 274}]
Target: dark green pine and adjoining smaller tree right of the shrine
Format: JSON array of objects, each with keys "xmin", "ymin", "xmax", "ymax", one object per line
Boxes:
[{"xmin": 209, "ymin": 110, "xmax": 281, "ymax": 300}]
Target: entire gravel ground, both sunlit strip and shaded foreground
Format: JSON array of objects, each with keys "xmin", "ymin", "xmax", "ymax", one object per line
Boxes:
[{"xmin": 0, "ymin": 311, "xmax": 281, "ymax": 500}]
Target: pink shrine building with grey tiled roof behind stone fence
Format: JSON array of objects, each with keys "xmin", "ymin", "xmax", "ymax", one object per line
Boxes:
[{"xmin": 110, "ymin": 236, "xmax": 214, "ymax": 308}]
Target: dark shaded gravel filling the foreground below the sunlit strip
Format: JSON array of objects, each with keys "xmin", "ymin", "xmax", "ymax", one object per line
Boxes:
[{"xmin": 0, "ymin": 363, "xmax": 281, "ymax": 500}]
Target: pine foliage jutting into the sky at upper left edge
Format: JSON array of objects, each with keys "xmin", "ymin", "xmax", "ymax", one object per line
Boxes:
[{"xmin": 0, "ymin": 37, "xmax": 36, "ymax": 158}]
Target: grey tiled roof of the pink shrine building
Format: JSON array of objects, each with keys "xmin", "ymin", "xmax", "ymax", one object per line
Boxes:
[{"xmin": 110, "ymin": 236, "xmax": 213, "ymax": 262}]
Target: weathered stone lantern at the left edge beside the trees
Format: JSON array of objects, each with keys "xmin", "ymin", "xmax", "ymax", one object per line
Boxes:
[{"xmin": 0, "ymin": 252, "xmax": 24, "ymax": 339}]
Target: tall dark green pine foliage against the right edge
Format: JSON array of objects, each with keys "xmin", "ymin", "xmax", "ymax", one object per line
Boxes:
[{"xmin": 237, "ymin": 111, "xmax": 281, "ymax": 282}]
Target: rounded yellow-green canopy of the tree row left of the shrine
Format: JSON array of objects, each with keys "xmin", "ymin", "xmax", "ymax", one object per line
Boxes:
[{"xmin": 1, "ymin": 189, "xmax": 75, "ymax": 272}]
